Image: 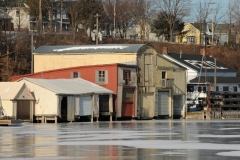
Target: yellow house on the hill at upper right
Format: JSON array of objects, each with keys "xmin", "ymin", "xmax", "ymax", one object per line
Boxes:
[{"xmin": 176, "ymin": 23, "xmax": 205, "ymax": 44}]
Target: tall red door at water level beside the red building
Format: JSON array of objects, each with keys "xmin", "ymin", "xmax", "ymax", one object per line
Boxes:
[{"xmin": 122, "ymin": 88, "xmax": 134, "ymax": 117}]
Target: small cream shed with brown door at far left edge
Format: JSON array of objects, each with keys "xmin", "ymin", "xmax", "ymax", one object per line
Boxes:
[{"xmin": 0, "ymin": 82, "xmax": 35, "ymax": 121}]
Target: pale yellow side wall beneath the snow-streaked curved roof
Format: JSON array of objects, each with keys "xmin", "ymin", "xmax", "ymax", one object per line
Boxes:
[{"xmin": 34, "ymin": 53, "xmax": 136, "ymax": 73}]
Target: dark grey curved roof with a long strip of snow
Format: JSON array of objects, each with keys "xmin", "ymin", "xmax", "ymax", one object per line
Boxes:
[{"xmin": 33, "ymin": 44, "xmax": 144, "ymax": 54}]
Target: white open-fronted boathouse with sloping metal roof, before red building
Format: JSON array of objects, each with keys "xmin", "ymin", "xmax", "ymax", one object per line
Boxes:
[{"xmin": 17, "ymin": 78, "xmax": 113, "ymax": 122}]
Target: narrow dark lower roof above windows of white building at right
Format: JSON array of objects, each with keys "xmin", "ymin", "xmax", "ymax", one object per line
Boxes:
[{"xmin": 190, "ymin": 77, "xmax": 240, "ymax": 83}]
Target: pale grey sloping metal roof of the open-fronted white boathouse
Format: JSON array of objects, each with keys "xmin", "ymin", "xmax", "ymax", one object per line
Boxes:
[{"xmin": 20, "ymin": 78, "xmax": 113, "ymax": 95}]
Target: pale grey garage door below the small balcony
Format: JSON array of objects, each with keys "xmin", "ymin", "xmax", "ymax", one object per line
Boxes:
[{"xmin": 158, "ymin": 92, "xmax": 169, "ymax": 115}]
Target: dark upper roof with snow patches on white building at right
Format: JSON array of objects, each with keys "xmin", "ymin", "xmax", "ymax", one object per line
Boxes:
[{"xmin": 164, "ymin": 53, "xmax": 237, "ymax": 72}]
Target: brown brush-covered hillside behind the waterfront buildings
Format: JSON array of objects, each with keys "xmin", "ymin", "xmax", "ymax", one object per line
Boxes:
[{"xmin": 0, "ymin": 33, "xmax": 240, "ymax": 81}]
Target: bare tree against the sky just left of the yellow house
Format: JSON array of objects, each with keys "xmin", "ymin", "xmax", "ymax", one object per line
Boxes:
[{"xmin": 157, "ymin": 0, "xmax": 190, "ymax": 42}]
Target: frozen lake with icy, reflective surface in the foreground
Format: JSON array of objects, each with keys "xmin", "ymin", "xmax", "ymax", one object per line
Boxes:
[{"xmin": 0, "ymin": 120, "xmax": 240, "ymax": 160}]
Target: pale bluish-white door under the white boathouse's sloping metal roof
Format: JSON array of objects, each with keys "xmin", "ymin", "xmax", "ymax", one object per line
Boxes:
[{"xmin": 80, "ymin": 96, "xmax": 92, "ymax": 116}]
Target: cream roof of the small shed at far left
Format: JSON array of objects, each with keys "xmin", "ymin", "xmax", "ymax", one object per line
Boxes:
[{"xmin": 0, "ymin": 82, "xmax": 24, "ymax": 100}]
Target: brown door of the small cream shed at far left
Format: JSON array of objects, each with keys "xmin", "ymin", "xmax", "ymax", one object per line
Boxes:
[{"xmin": 17, "ymin": 101, "xmax": 31, "ymax": 120}]
